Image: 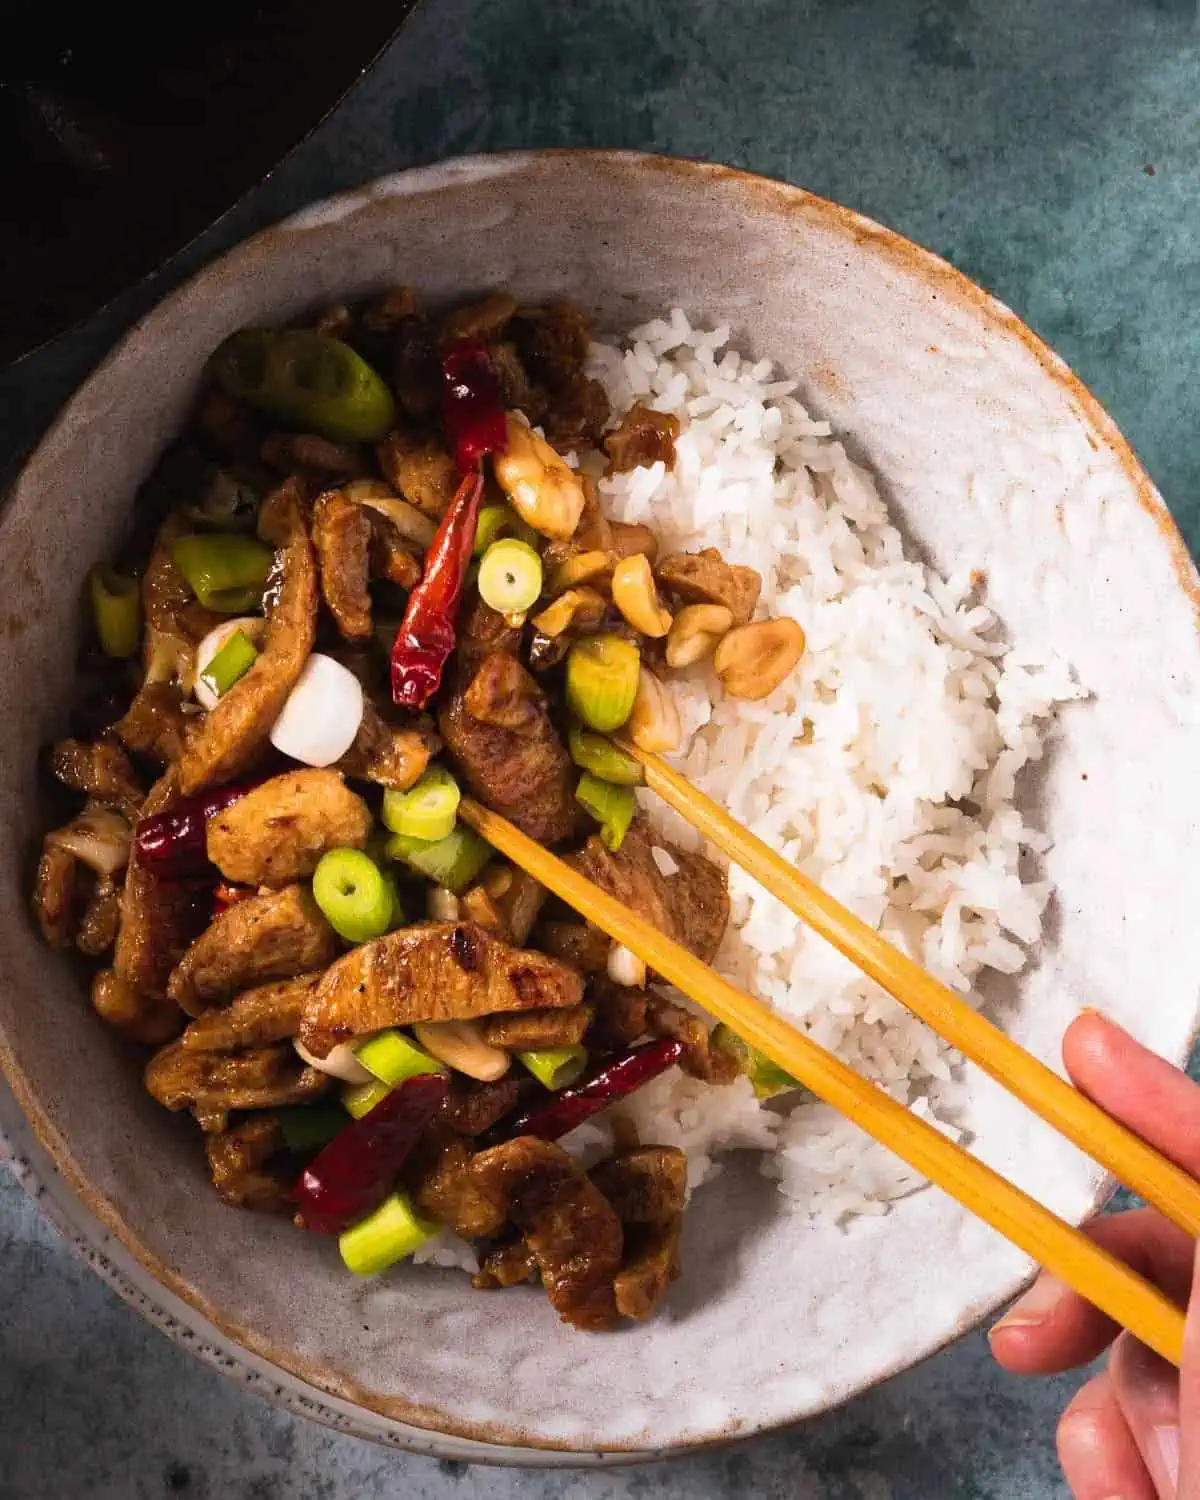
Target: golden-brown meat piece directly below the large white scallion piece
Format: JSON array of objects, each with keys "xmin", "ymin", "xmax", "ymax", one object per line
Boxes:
[{"xmin": 207, "ymin": 770, "xmax": 372, "ymax": 890}]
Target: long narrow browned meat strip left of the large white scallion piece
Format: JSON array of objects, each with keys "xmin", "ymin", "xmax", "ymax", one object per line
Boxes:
[{"xmin": 180, "ymin": 480, "xmax": 317, "ymax": 797}]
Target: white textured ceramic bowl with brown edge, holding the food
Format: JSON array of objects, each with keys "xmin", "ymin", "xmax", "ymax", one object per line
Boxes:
[{"xmin": 0, "ymin": 153, "xmax": 1200, "ymax": 1463}]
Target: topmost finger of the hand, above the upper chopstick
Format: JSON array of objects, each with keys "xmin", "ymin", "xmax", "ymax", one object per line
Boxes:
[{"xmin": 1062, "ymin": 1011, "xmax": 1200, "ymax": 1178}]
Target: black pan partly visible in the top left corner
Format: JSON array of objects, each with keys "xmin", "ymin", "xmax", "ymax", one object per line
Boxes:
[{"xmin": 0, "ymin": 0, "xmax": 417, "ymax": 365}]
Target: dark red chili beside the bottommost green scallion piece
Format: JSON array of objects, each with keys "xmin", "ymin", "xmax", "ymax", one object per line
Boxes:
[{"xmin": 293, "ymin": 1073, "xmax": 449, "ymax": 1235}]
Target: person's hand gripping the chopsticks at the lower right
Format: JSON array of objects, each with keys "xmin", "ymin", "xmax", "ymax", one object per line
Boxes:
[{"xmin": 989, "ymin": 1011, "xmax": 1200, "ymax": 1500}]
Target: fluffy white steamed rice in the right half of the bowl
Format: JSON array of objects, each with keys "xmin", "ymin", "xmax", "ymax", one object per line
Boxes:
[{"xmin": 419, "ymin": 309, "xmax": 1083, "ymax": 1265}]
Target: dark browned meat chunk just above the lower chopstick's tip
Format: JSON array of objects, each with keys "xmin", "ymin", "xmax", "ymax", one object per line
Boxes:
[{"xmin": 438, "ymin": 656, "xmax": 584, "ymax": 845}]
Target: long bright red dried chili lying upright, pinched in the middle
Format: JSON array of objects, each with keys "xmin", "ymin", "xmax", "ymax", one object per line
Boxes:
[{"xmin": 392, "ymin": 339, "xmax": 506, "ymax": 711}]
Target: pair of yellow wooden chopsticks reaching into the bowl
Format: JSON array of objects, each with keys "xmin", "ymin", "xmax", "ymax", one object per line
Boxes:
[{"xmin": 459, "ymin": 744, "xmax": 1200, "ymax": 1365}]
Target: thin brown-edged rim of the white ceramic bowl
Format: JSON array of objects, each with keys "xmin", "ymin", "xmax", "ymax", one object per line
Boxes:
[{"xmin": 0, "ymin": 147, "xmax": 1200, "ymax": 1467}]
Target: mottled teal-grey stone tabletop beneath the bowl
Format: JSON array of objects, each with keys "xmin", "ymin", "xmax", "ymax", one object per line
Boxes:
[{"xmin": 0, "ymin": 0, "xmax": 1200, "ymax": 1500}]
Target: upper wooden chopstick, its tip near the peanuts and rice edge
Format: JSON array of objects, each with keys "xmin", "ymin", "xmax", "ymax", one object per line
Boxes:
[{"xmin": 621, "ymin": 740, "xmax": 1200, "ymax": 1239}]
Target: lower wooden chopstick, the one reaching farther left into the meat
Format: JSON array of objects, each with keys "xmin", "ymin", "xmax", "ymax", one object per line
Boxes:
[{"xmin": 459, "ymin": 798, "xmax": 1184, "ymax": 1365}]
